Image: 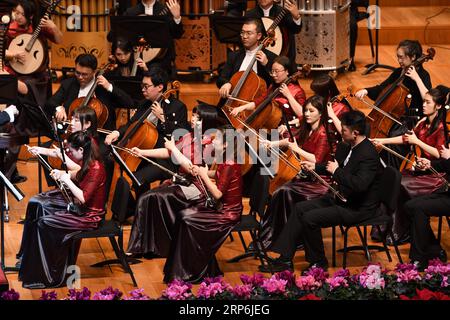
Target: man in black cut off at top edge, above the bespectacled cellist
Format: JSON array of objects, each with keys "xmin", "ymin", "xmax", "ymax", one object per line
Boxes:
[{"xmin": 245, "ymin": 0, "xmax": 302, "ymax": 65}]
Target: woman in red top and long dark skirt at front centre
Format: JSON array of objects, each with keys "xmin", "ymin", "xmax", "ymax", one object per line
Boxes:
[{"xmin": 164, "ymin": 126, "xmax": 242, "ymax": 282}]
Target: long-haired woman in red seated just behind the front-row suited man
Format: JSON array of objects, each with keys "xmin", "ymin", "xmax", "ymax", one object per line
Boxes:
[{"xmin": 260, "ymin": 96, "xmax": 333, "ymax": 248}]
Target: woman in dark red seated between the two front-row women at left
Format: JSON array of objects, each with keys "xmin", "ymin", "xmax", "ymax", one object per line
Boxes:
[{"xmin": 128, "ymin": 104, "xmax": 218, "ymax": 258}]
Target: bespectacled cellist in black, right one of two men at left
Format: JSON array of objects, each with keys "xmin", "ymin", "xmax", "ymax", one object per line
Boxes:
[{"xmin": 105, "ymin": 67, "xmax": 189, "ymax": 200}]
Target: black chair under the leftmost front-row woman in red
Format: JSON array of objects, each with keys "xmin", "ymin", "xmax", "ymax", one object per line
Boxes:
[{"xmin": 74, "ymin": 177, "xmax": 140, "ymax": 287}]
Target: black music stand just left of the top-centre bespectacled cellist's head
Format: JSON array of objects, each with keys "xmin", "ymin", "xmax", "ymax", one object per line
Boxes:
[{"xmin": 209, "ymin": 15, "xmax": 248, "ymax": 45}]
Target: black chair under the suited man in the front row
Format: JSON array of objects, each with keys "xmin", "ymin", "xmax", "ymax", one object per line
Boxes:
[{"xmin": 332, "ymin": 166, "xmax": 403, "ymax": 269}]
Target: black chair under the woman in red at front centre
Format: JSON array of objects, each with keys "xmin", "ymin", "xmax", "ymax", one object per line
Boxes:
[{"xmin": 227, "ymin": 174, "xmax": 270, "ymax": 267}]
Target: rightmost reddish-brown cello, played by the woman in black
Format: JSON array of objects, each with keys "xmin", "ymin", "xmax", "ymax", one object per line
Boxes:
[{"xmin": 364, "ymin": 48, "xmax": 436, "ymax": 138}]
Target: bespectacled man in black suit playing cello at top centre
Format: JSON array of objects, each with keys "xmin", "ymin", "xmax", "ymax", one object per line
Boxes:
[{"xmin": 216, "ymin": 19, "xmax": 276, "ymax": 98}]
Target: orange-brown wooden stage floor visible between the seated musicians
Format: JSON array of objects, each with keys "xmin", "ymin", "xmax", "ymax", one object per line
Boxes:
[{"xmin": 5, "ymin": 46, "xmax": 450, "ymax": 299}]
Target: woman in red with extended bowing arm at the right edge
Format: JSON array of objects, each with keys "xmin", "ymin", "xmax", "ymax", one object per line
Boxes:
[{"xmin": 372, "ymin": 88, "xmax": 447, "ymax": 244}]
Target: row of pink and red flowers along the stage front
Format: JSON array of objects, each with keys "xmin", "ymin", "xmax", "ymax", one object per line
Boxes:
[{"xmin": 0, "ymin": 259, "xmax": 450, "ymax": 300}]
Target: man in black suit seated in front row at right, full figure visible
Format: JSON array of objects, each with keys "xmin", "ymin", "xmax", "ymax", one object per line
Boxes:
[{"xmin": 261, "ymin": 111, "xmax": 383, "ymax": 271}]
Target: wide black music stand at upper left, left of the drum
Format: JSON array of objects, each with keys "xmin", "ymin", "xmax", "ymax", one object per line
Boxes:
[{"xmin": 111, "ymin": 16, "xmax": 172, "ymax": 48}]
